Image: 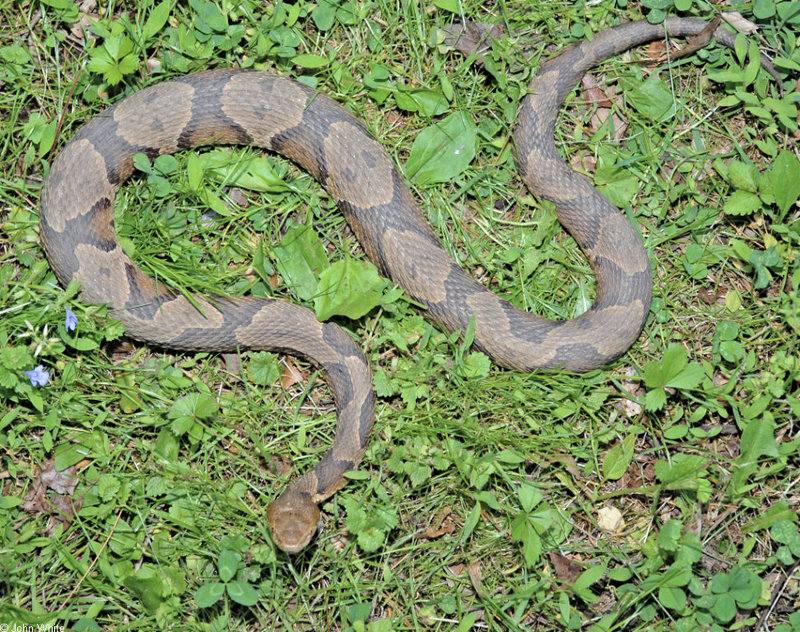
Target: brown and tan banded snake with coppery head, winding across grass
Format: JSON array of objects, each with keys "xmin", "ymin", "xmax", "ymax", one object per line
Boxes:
[{"xmin": 40, "ymin": 18, "xmax": 780, "ymax": 553}]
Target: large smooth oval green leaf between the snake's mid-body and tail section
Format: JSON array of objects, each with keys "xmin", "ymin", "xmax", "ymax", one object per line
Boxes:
[{"xmin": 406, "ymin": 112, "xmax": 477, "ymax": 184}]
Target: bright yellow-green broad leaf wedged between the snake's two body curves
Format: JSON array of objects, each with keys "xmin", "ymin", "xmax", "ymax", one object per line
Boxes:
[{"xmin": 314, "ymin": 257, "xmax": 387, "ymax": 321}]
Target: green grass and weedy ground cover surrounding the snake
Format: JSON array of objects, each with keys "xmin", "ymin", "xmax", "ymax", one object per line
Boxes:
[{"xmin": 0, "ymin": 0, "xmax": 800, "ymax": 632}]
